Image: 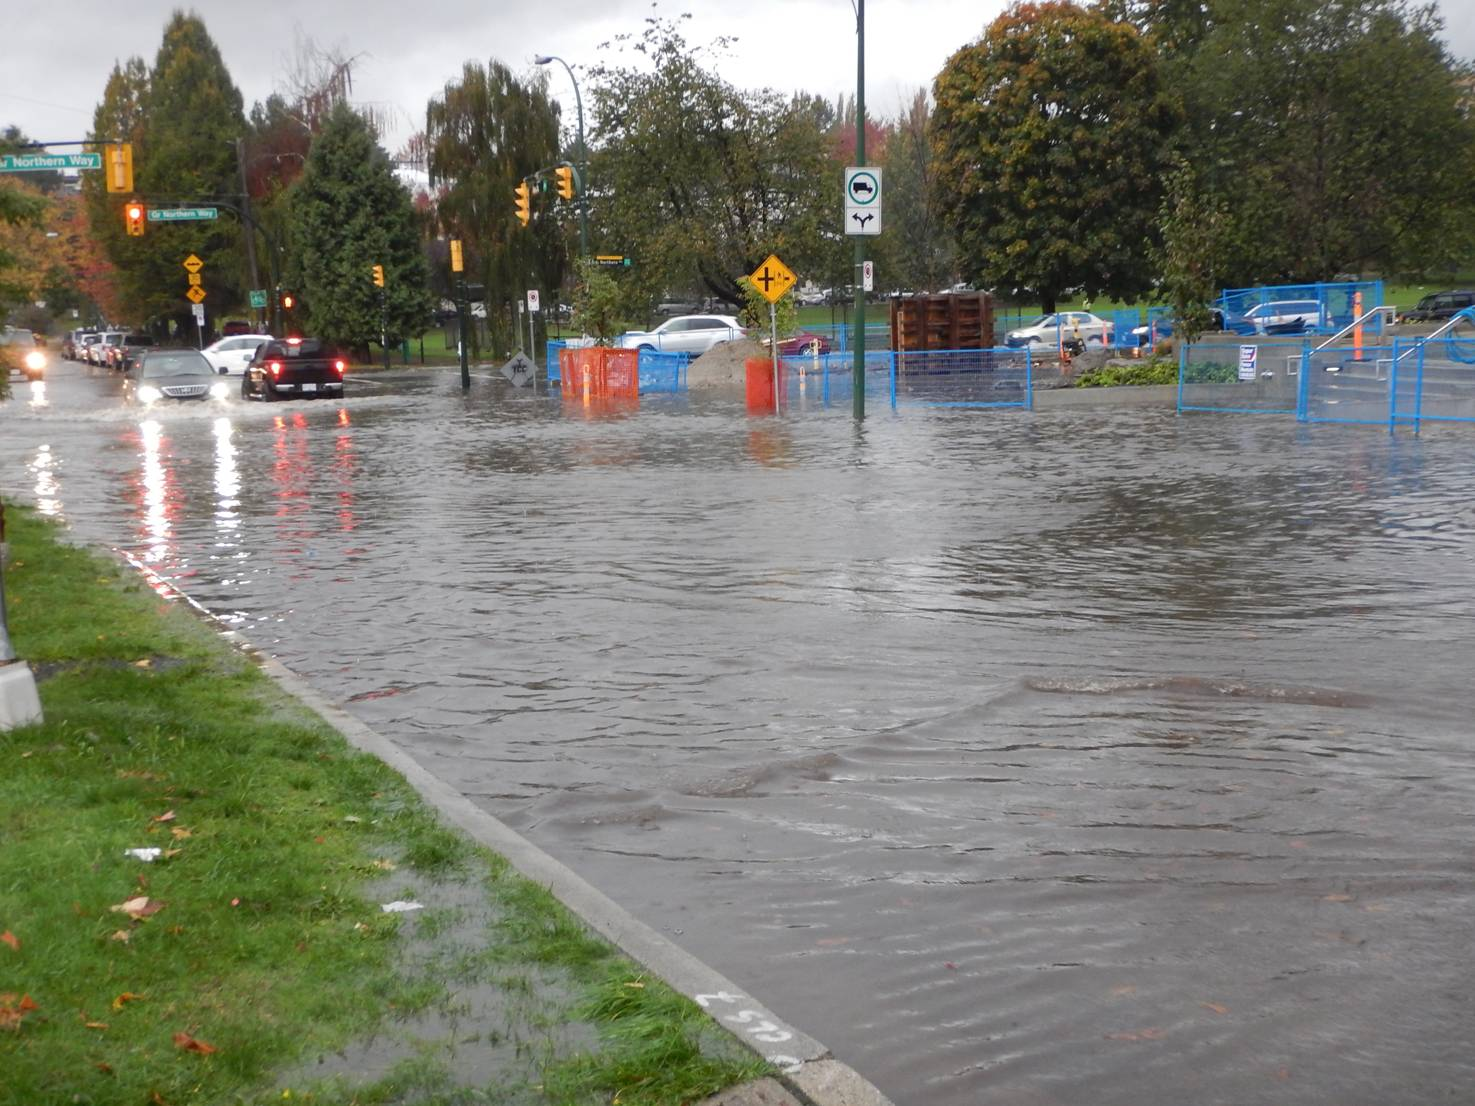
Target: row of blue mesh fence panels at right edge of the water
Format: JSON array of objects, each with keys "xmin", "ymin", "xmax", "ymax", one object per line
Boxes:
[{"xmin": 1179, "ymin": 310, "xmax": 1475, "ymax": 431}]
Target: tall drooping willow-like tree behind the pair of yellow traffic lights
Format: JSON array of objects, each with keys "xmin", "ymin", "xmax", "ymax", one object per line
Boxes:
[{"xmin": 425, "ymin": 62, "xmax": 572, "ymax": 349}]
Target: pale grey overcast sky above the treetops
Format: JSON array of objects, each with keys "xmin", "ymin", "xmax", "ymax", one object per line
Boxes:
[{"xmin": 0, "ymin": 0, "xmax": 1475, "ymax": 152}]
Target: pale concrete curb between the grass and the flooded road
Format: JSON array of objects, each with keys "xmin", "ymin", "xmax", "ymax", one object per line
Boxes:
[{"xmin": 114, "ymin": 549, "xmax": 894, "ymax": 1106}]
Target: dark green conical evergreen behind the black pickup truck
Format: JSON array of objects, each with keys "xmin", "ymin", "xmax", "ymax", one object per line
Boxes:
[{"xmin": 288, "ymin": 103, "xmax": 434, "ymax": 348}]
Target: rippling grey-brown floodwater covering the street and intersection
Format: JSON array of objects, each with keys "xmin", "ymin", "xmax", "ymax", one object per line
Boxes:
[{"xmin": 0, "ymin": 369, "xmax": 1475, "ymax": 1106}]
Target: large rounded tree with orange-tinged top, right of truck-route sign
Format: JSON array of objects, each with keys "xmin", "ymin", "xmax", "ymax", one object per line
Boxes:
[{"xmin": 931, "ymin": 0, "xmax": 1180, "ymax": 311}]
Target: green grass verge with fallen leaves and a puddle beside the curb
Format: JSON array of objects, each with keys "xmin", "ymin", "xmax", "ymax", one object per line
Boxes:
[{"xmin": 0, "ymin": 509, "xmax": 764, "ymax": 1106}]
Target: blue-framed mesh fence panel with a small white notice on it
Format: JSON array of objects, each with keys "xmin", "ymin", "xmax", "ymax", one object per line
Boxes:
[{"xmin": 1179, "ymin": 341, "xmax": 1310, "ymax": 414}]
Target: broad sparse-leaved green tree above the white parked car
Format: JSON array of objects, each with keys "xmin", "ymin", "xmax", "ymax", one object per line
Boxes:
[{"xmin": 590, "ymin": 18, "xmax": 838, "ymax": 304}]
